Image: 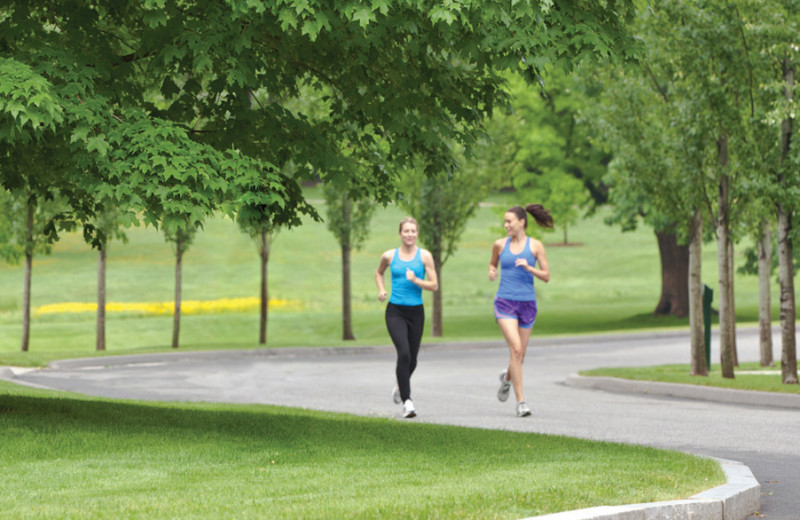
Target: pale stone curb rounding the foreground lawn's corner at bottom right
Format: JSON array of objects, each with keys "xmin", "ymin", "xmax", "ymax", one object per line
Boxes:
[{"xmin": 524, "ymin": 459, "xmax": 761, "ymax": 520}]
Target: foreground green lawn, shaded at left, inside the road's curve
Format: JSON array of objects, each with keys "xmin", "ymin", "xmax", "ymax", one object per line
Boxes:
[{"xmin": 0, "ymin": 382, "xmax": 724, "ymax": 520}]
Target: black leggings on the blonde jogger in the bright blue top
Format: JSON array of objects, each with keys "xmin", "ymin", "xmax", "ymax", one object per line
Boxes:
[{"xmin": 386, "ymin": 303, "xmax": 425, "ymax": 402}]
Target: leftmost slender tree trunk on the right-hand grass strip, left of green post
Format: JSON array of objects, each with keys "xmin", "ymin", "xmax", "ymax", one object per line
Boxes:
[{"xmin": 689, "ymin": 210, "xmax": 708, "ymax": 376}]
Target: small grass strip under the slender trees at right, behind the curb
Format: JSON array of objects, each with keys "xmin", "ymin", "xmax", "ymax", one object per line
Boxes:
[{"xmin": 581, "ymin": 362, "xmax": 800, "ymax": 394}]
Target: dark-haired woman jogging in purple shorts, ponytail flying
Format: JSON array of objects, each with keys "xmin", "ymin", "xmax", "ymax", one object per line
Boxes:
[{"xmin": 489, "ymin": 204, "xmax": 553, "ymax": 417}]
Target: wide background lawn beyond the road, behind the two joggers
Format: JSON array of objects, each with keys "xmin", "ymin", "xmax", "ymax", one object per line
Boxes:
[{"xmin": 0, "ymin": 189, "xmax": 777, "ymax": 366}]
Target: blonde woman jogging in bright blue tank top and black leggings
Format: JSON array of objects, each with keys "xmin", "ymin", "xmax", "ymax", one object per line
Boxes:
[{"xmin": 375, "ymin": 217, "xmax": 439, "ymax": 419}]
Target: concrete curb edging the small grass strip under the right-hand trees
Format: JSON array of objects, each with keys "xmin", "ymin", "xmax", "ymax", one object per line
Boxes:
[{"xmin": 564, "ymin": 374, "xmax": 800, "ymax": 409}]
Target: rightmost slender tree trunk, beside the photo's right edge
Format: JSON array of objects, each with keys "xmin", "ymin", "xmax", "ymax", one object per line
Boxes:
[{"xmin": 778, "ymin": 58, "xmax": 797, "ymax": 385}]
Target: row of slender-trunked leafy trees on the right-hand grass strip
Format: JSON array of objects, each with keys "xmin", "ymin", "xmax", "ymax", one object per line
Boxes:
[{"xmin": 584, "ymin": 0, "xmax": 800, "ymax": 384}]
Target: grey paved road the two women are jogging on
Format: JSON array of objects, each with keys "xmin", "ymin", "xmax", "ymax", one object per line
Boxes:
[{"xmin": 7, "ymin": 329, "xmax": 800, "ymax": 520}]
